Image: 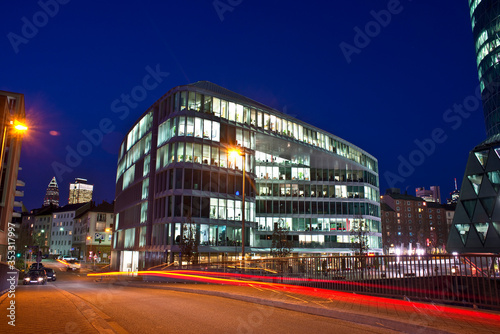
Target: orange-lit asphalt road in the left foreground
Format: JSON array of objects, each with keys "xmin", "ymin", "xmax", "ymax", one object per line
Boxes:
[{"xmin": 0, "ymin": 262, "xmax": 398, "ymax": 334}]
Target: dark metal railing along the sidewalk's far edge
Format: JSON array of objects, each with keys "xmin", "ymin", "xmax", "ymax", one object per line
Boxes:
[{"xmin": 199, "ymin": 254, "xmax": 500, "ymax": 309}]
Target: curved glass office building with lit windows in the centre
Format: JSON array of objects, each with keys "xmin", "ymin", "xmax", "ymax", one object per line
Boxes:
[{"xmin": 112, "ymin": 81, "xmax": 382, "ymax": 270}]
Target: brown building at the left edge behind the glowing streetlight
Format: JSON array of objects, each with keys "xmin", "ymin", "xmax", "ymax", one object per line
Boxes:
[{"xmin": 0, "ymin": 91, "xmax": 26, "ymax": 262}]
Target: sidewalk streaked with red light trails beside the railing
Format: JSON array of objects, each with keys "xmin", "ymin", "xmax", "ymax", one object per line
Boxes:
[{"xmin": 115, "ymin": 278, "xmax": 500, "ymax": 333}]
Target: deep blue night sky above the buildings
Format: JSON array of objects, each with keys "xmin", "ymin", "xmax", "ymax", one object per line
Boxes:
[{"xmin": 0, "ymin": 0, "xmax": 485, "ymax": 209}]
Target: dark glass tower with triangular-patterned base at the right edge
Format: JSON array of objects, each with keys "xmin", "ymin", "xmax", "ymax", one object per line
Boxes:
[{"xmin": 447, "ymin": 0, "xmax": 500, "ymax": 253}]
